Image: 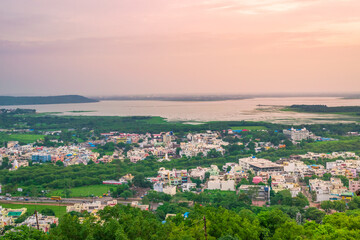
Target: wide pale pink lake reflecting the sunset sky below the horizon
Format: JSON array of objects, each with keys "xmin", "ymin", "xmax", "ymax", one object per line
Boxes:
[{"xmin": 4, "ymin": 97, "xmax": 360, "ymax": 124}]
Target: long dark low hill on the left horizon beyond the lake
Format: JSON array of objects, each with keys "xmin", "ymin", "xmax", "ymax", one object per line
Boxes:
[{"xmin": 0, "ymin": 95, "xmax": 98, "ymax": 106}]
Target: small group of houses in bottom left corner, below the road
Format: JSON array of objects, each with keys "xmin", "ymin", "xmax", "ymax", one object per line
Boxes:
[{"xmin": 0, "ymin": 206, "xmax": 59, "ymax": 232}]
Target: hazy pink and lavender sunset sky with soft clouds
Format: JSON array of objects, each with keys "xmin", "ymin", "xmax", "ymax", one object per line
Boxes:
[{"xmin": 0, "ymin": 0, "xmax": 360, "ymax": 96}]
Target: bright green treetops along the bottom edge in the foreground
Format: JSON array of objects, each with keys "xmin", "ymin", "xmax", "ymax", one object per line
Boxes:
[{"xmin": 0, "ymin": 205, "xmax": 360, "ymax": 240}]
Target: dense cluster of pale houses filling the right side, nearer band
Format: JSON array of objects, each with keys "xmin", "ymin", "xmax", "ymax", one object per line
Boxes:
[{"xmin": 139, "ymin": 153, "xmax": 360, "ymax": 205}]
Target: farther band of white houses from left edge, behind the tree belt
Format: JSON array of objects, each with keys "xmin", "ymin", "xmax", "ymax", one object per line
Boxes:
[{"xmin": 0, "ymin": 128, "xmax": 332, "ymax": 170}]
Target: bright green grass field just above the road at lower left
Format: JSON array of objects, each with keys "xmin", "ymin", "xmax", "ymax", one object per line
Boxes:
[{"xmin": 48, "ymin": 184, "xmax": 112, "ymax": 197}]
